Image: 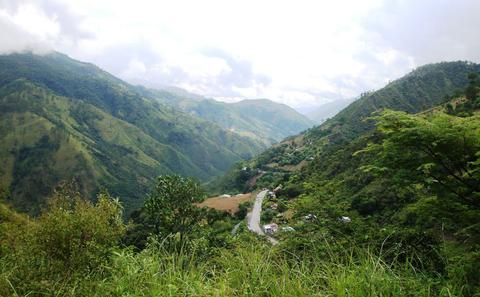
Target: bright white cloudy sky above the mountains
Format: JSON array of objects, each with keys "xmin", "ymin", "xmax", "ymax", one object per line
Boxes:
[{"xmin": 0, "ymin": 0, "xmax": 480, "ymax": 110}]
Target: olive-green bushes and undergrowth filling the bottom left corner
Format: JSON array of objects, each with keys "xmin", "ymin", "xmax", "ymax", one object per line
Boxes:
[{"xmin": 0, "ymin": 185, "xmax": 126, "ymax": 296}]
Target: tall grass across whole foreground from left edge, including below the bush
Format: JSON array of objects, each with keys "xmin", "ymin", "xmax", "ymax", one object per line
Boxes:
[{"xmin": 0, "ymin": 230, "xmax": 462, "ymax": 297}]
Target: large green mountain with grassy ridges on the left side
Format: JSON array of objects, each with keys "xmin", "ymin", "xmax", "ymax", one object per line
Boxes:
[{"xmin": 0, "ymin": 53, "xmax": 264, "ymax": 211}]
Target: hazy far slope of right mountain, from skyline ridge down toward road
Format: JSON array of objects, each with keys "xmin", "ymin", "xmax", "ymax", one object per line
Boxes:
[{"xmin": 214, "ymin": 62, "xmax": 480, "ymax": 192}]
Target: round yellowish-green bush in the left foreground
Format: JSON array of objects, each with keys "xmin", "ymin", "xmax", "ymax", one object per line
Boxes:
[{"xmin": 37, "ymin": 186, "xmax": 125, "ymax": 271}]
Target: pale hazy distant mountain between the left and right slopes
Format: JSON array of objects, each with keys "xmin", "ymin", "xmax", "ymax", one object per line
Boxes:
[{"xmin": 135, "ymin": 87, "xmax": 314, "ymax": 146}]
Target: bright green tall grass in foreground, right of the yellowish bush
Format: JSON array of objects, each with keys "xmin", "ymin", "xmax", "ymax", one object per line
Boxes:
[{"xmin": 90, "ymin": 238, "xmax": 460, "ymax": 297}]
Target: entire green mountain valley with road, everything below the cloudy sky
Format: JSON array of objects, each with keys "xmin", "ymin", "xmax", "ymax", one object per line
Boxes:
[{"xmin": 0, "ymin": 53, "xmax": 480, "ymax": 296}]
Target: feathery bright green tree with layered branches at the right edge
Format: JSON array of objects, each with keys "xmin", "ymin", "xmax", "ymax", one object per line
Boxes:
[{"xmin": 367, "ymin": 111, "xmax": 480, "ymax": 209}]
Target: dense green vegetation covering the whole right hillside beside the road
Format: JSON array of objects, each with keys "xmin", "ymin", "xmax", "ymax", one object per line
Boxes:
[{"xmin": 211, "ymin": 63, "xmax": 480, "ymax": 296}]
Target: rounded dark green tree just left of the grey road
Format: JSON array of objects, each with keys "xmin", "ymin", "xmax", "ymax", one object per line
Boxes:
[{"xmin": 145, "ymin": 175, "xmax": 205, "ymax": 242}]
